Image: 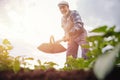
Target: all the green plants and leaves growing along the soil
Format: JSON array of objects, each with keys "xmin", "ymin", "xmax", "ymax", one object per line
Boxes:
[{"xmin": 0, "ymin": 25, "xmax": 120, "ymax": 79}]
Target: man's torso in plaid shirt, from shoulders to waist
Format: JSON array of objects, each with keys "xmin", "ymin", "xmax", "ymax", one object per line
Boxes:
[{"xmin": 61, "ymin": 10, "xmax": 86, "ymax": 41}]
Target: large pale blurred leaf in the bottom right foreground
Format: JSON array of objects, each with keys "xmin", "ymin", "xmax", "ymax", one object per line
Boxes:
[{"xmin": 94, "ymin": 44, "xmax": 120, "ymax": 80}]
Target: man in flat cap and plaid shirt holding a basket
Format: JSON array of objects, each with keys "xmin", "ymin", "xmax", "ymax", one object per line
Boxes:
[{"xmin": 58, "ymin": 1, "xmax": 88, "ymax": 59}]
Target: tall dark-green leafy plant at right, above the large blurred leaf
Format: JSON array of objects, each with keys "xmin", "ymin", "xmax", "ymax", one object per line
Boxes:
[{"xmin": 87, "ymin": 26, "xmax": 120, "ymax": 58}]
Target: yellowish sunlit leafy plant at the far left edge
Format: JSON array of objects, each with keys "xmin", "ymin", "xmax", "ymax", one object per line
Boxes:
[{"xmin": 0, "ymin": 39, "xmax": 20, "ymax": 72}]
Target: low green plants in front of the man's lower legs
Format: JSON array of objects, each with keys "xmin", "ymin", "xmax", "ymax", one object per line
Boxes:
[{"xmin": 61, "ymin": 56, "xmax": 92, "ymax": 70}]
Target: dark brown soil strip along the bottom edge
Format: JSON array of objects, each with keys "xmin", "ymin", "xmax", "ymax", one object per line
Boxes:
[{"xmin": 0, "ymin": 67, "xmax": 120, "ymax": 80}]
